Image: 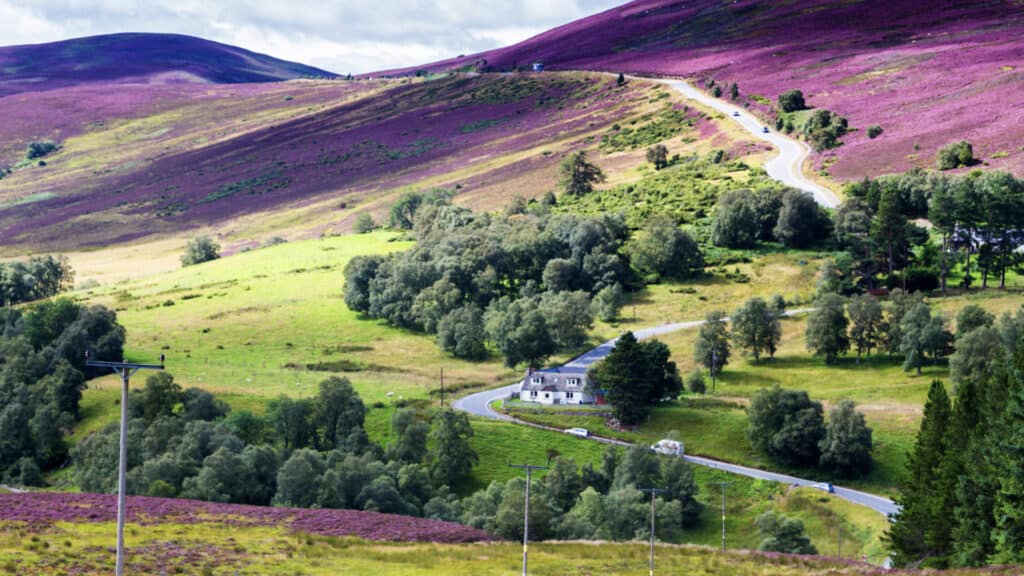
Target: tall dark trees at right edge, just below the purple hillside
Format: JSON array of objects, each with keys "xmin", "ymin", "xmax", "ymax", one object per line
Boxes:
[{"xmin": 835, "ymin": 170, "xmax": 1024, "ymax": 291}]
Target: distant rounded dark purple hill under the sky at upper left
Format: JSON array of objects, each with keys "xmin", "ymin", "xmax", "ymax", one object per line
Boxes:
[{"xmin": 0, "ymin": 34, "xmax": 335, "ymax": 96}]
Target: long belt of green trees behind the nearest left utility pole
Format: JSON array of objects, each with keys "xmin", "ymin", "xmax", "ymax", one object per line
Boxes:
[{"xmin": 75, "ymin": 372, "xmax": 477, "ymax": 516}]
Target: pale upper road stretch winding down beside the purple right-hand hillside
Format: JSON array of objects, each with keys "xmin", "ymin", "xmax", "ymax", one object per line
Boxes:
[{"xmin": 658, "ymin": 80, "xmax": 840, "ymax": 208}]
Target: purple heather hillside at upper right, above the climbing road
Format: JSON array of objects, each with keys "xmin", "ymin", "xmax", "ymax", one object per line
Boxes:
[{"xmin": 385, "ymin": 0, "xmax": 1024, "ymax": 179}]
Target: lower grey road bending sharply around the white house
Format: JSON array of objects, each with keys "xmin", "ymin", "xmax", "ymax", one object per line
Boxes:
[{"xmin": 452, "ymin": 308, "xmax": 899, "ymax": 517}]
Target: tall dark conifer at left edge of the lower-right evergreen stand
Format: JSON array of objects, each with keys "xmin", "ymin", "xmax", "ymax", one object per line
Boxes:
[{"xmin": 888, "ymin": 380, "xmax": 950, "ymax": 566}]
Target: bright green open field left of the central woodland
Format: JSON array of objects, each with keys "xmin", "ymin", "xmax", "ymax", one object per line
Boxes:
[{"xmin": 78, "ymin": 228, "xmax": 520, "ymax": 404}]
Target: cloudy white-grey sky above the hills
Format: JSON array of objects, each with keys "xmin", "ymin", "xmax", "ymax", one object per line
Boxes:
[{"xmin": 0, "ymin": 0, "xmax": 626, "ymax": 74}]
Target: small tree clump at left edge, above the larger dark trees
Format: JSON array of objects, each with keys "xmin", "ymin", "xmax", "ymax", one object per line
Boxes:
[{"xmin": 0, "ymin": 256, "xmax": 75, "ymax": 307}]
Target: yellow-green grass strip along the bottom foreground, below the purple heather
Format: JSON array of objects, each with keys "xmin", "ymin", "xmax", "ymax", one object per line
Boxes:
[{"xmin": 0, "ymin": 516, "xmax": 937, "ymax": 576}]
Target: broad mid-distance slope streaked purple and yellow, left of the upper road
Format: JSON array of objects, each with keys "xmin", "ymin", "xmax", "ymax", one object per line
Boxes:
[{"xmin": 0, "ymin": 74, "xmax": 735, "ymax": 250}]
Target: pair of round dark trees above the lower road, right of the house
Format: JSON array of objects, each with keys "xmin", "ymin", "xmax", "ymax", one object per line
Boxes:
[{"xmin": 746, "ymin": 386, "xmax": 871, "ymax": 477}]
